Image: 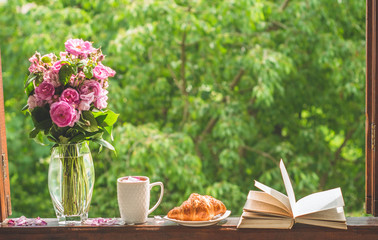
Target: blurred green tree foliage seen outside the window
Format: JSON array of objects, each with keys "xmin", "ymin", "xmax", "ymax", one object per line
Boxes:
[{"xmin": 0, "ymin": 0, "xmax": 365, "ymax": 217}]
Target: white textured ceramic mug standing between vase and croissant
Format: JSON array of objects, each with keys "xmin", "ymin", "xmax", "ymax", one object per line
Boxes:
[{"xmin": 117, "ymin": 176, "xmax": 164, "ymax": 224}]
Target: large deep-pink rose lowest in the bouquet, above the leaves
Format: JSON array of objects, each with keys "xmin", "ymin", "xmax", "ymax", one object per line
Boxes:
[{"xmin": 50, "ymin": 101, "xmax": 80, "ymax": 127}]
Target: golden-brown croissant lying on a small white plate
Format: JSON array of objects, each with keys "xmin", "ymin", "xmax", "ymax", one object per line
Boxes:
[{"xmin": 168, "ymin": 193, "xmax": 226, "ymax": 221}]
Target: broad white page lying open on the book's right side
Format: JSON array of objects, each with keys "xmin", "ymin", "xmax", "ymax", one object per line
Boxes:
[{"xmin": 294, "ymin": 188, "xmax": 344, "ymax": 217}]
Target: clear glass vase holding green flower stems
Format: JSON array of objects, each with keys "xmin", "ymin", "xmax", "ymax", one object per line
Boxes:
[{"xmin": 48, "ymin": 142, "xmax": 95, "ymax": 224}]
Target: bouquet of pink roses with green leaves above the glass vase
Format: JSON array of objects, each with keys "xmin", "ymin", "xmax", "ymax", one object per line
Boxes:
[{"xmin": 23, "ymin": 39, "xmax": 118, "ymax": 150}]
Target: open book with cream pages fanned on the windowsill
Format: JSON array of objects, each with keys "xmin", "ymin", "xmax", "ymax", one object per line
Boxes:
[{"xmin": 238, "ymin": 160, "xmax": 347, "ymax": 229}]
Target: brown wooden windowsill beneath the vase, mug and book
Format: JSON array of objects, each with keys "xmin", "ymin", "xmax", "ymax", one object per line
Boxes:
[{"xmin": 0, "ymin": 217, "xmax": 378, "ymax": 240}]
